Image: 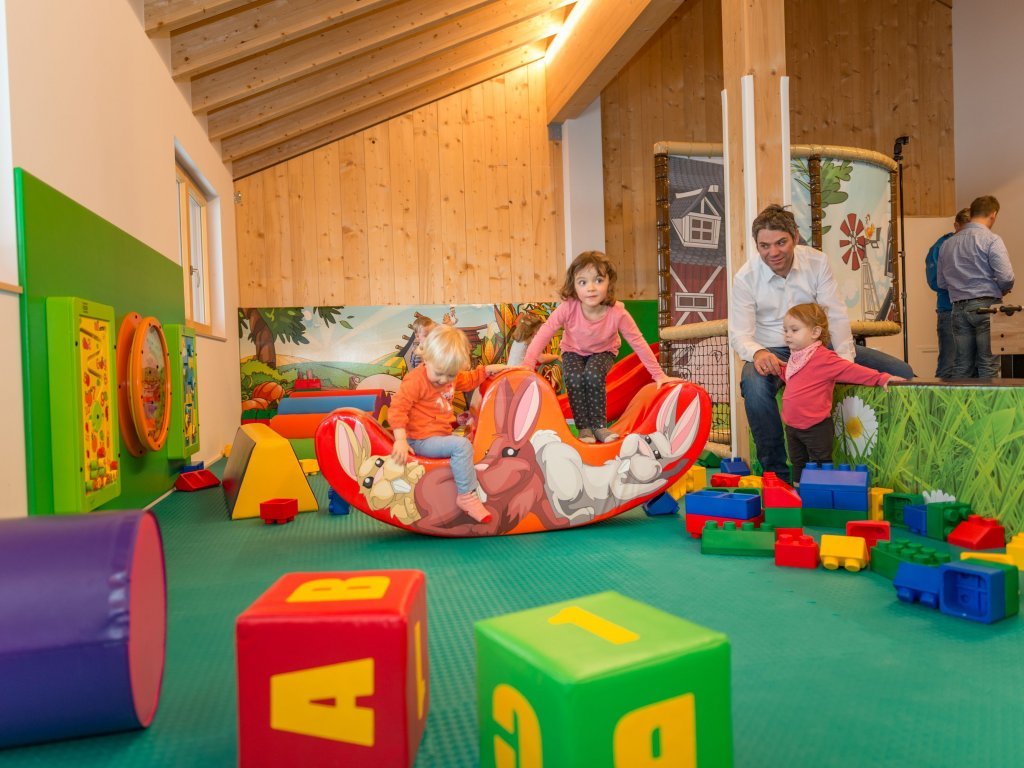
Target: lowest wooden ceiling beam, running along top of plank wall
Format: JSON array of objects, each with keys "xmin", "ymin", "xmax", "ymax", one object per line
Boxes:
[{"xmin": 231, "ymin": 44, "xmax": 546, "ymax": 179}]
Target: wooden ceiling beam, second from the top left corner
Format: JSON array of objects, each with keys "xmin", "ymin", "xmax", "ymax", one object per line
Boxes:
[{"xmin": 171, "ymin": 0, "xmax": 400, "ymax": 78}]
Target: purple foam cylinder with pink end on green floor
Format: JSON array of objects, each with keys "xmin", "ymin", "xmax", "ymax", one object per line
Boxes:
[{"xmin": 0, "ymin": 510, "xmax": 167, "ymax": 746}]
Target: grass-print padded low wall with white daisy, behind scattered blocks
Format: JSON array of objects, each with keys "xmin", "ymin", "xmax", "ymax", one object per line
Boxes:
[{"xmin": 835, "ymin": 384, "xmax": 1024, "ymax": 536}]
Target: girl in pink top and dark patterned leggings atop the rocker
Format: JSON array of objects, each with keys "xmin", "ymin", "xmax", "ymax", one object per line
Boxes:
[{"xmin": 522, "ymin": 251, "xmax": 679, "ymax": 442}]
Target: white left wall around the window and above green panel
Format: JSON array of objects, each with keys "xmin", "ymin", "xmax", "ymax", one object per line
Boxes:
[{"xmin": 0, "ymin": 0, "xmax": 241, "ymax": 516}]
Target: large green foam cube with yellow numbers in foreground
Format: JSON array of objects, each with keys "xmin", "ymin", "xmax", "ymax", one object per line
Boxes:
[{"xmin": 474, "ymin": 592, "xmax": 732, "ymax": 768}]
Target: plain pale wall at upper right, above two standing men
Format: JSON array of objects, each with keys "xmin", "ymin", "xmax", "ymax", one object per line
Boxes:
[{"xmin": 953, "ymin": 0, "xmax": 1024, "ymax": 280}]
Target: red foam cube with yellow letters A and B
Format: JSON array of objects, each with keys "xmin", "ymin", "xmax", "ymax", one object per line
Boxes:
[{"xmin": 236, "ymin": 570, "xmax": 430, "ymax": 768}]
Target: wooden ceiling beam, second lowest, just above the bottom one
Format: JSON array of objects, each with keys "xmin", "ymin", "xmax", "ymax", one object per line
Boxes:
[{"xmin": 207, "ymin": 2, "xmax": 566, "ymax": 139}]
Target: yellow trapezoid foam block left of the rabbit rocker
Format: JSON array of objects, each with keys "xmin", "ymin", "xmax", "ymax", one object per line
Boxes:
[{"xmin": 221, "ymin": 424, "xmax": 318, "ymax": 520}]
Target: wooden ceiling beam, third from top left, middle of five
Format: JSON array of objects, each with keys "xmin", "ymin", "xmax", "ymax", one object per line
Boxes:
[{"xmin": 191, "ymin": 0, "xmax": 568, "ymax": 112}]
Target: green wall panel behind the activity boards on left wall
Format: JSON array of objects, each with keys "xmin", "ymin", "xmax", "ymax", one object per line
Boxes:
[{"xmin": 14, "ymin": 168, "xmax": 184, "ymax": 514}]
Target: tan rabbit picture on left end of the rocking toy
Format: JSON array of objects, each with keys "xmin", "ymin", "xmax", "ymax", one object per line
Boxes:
[{"xmin": 335, "ymin": 421, "xmax": 425, "ymax": 525}]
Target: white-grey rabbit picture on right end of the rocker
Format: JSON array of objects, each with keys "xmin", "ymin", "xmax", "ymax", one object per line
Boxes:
[{"xmin": 531, "ymin": 386, "xmax": 700, "ymax": 524}]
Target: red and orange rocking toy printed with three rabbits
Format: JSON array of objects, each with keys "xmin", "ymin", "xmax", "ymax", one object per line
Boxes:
[{"xmin": 315, "ymin": 370, "xmax": 711, "ymax": 537}]
